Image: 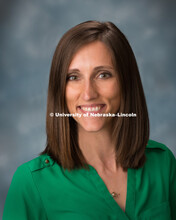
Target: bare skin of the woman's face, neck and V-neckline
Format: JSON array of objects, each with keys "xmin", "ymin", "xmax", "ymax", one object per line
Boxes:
[{"xmin": 66, "ymin": 41, "xmax": 127, "ymax": 210}]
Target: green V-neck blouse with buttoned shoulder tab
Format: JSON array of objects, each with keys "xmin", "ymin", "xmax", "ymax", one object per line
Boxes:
[{"xmin": 3, "ymin": 141, "xmax": 176, "ymax": 220}]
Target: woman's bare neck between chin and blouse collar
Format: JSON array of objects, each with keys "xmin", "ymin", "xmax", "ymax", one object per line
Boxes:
[{"xmin": 78, "ymin": 127, "xmax": 117, "ymax": 172}]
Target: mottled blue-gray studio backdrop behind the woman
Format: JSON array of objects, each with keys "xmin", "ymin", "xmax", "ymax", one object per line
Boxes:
[{"xmin": 0, "ymin": 0, "xmax": 176, "ymax": 217}]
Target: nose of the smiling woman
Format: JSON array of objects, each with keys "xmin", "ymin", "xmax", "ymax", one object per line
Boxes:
[{"xmin": 81, "ymin": 79, "xmax": 98, "ymax": 101}]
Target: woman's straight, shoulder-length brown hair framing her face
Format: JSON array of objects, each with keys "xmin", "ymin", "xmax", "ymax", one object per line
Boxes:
[{"xmin": 41, "ymin": 21, "xmax": 149, "ymax": 170}]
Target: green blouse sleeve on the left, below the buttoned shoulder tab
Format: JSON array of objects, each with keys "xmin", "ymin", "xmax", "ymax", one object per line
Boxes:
[{"xmin": 2, "ymin": 164, "xmax": 47, "ymax": 220}]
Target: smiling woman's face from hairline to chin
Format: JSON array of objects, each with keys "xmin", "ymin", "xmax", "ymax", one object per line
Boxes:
[{"xmin": 66, "ymin": 41, "xmax": 120, "ymax": 133}]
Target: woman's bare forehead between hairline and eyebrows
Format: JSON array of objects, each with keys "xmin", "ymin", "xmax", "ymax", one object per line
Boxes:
[{"xmin": 69, "ymin": 41, "xmax": 113, "ymax": 69}]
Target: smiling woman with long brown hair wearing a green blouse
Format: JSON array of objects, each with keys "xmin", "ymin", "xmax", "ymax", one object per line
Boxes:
[{"xmin": 3, "ymin": 21, "xmax": 176, "ymax": 220}]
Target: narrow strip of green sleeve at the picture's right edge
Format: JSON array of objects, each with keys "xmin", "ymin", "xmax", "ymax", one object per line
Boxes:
[{"xmin": 168, "ymin": 150, "xmax": 176, "ymax": 220}]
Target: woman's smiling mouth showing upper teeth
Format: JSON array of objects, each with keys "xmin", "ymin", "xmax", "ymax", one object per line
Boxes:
[{"xmin": 77, "ymin": 104, "xmax": 106, "ymax": 113}]
